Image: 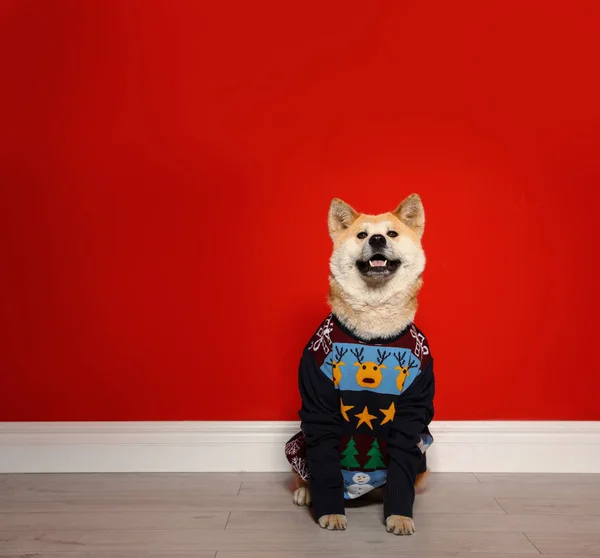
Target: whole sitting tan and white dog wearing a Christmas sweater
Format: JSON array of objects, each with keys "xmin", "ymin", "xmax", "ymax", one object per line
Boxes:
[{"xmin": 286, "ymin": 194, "xmax": 435, "ymax": 535}]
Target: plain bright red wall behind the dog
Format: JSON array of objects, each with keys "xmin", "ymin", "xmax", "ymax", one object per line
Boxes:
[{"xmin": 0, "ymin": 0, "xmax": 600, "ymax": 420}]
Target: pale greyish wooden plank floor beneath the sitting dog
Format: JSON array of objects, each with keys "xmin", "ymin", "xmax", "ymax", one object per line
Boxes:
[{"xmin": 0, "ymin": 473, "xmax": 600, "ymax": 558}]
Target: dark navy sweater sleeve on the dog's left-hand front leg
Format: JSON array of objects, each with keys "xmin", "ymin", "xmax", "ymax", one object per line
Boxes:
[{"xmin": 299, "ymin": 349, "xmax": 344, "ymax": 519}]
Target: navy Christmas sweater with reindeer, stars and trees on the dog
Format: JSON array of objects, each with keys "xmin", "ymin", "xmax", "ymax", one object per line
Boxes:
[{"xmin": 299, "ymin": 315, "xmax": 435, "ymax": 518}]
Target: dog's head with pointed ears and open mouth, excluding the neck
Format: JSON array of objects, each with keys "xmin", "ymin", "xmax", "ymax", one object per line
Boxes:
[{"xmin": 329, "ymin": 194, "xmax": 425, "ymax": 296}]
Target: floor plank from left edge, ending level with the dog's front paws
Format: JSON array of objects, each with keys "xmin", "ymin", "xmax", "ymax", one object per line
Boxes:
[{"xmin": 0, "ymin": 511, "xmax": 229, "ymax": 531}]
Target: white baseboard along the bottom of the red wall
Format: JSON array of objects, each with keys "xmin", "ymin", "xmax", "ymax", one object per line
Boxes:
[{"xmin": 0, "ymin": 421, "xmax": 600, "ymax": 473}]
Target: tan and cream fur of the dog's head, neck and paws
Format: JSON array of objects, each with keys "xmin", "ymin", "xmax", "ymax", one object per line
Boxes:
[{"xmin": 294, "ymin": 194, "xmax": 427, "ymax": 535}]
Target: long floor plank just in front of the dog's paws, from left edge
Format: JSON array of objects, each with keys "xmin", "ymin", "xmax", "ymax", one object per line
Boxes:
[{"xmin": 0, "ymin": 529, "xmax": 538, "ymax": 555}]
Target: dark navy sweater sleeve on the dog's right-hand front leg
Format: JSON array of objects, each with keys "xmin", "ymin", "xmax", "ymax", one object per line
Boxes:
[{"xmin": 384, "ymin": 360, "xmax": 435, "ymax": 518}]
